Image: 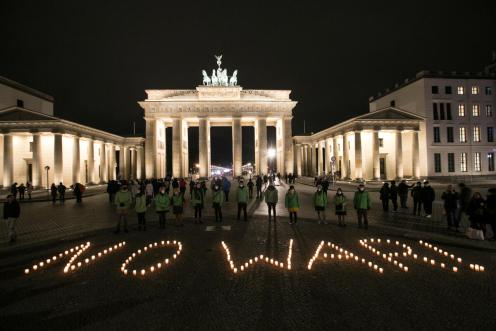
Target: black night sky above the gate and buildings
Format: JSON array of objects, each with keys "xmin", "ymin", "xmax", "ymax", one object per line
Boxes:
[{"xmin": 0, "ymin": 0, "xmax": 496, "ymax": 166}]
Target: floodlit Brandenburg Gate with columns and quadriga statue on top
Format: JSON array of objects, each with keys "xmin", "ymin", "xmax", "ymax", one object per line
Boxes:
[{"xmin": 139, "ymin": 55, "xmax": 296, "ymax": 178}]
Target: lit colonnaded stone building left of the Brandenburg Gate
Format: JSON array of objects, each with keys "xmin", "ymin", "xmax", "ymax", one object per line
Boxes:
[{"xmin": 0, "ymin": 77, "xmax": 144, "ymax": 187}]
